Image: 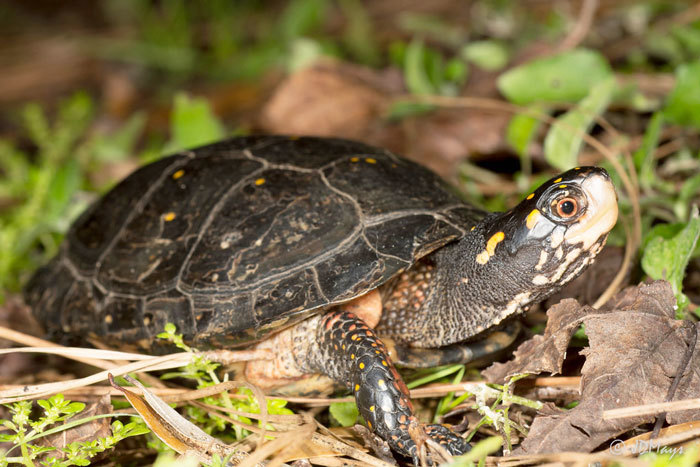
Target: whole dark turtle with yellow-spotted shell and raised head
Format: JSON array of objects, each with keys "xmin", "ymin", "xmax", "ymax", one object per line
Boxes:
[{"xmin": 25, "ymin": 135, "xmax": 617, "ymax": 463}]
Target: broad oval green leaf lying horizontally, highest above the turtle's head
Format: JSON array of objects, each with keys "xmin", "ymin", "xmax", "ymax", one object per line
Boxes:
[{"xmin": 498, "ymin": 49, "xmax": 612, "ymax": 105}]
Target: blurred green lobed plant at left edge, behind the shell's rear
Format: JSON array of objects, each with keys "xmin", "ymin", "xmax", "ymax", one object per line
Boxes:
[{"xmin": 0, "ymin": 93, "xmax": 145, "ymax": 303}]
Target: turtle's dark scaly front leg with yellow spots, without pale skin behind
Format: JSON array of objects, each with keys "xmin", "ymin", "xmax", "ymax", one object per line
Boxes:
[{"xmin": 306, "ymin": 309, "xmax": 470, "ymax": 465}]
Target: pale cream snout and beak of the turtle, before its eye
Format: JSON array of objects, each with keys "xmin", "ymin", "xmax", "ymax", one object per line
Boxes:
[{"xmin": 564, "ymin": 172, "xmax": 617, "ymax": 250}]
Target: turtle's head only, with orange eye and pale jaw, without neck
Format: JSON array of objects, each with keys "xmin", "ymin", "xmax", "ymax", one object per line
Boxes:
[{"xmin": 476, "ymin": 167, "xmax": 617, "ymax": 299}]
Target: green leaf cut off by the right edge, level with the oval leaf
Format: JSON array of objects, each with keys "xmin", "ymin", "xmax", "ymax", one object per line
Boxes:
[{"xmin": 664, "ymin": 61, "xmax": 700, "ymax": 128}]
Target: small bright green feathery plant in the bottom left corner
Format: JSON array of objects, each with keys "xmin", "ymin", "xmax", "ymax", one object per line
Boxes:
[{"xmin": 0, "ymin": 394, "xmax": 150, "ymax": 467}]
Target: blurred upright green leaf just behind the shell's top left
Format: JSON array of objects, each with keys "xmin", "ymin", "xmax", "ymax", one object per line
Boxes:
[{"xmin": 168, "ymin": 93, "xmax": 224, "ymax": 150}]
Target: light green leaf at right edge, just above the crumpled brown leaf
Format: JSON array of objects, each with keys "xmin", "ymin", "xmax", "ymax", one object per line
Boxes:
[{"xmin": 642, "ymin": 206, "xmax": 700, "ymax": 312}]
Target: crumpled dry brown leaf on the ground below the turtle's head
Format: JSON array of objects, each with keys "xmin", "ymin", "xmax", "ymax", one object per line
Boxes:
[{"xmin": 486, "ymin": 281, "xmax": 700, "ymax": 454}]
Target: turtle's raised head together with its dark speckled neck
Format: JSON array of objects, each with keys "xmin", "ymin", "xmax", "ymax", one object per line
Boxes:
[{"xmin": 380, "ymin": 167, "xmax": 617, "ymax": 347}]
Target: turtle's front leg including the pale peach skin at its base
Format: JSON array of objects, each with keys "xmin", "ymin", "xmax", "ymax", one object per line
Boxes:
[{"xmin": 246, "ymin": 302, "xmax": 471, "ymax": 465}]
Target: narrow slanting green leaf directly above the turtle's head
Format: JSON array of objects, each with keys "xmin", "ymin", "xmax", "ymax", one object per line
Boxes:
[{"xmin": 544, "ymin": 78, "xmax": 615, "ymax": 170}]
